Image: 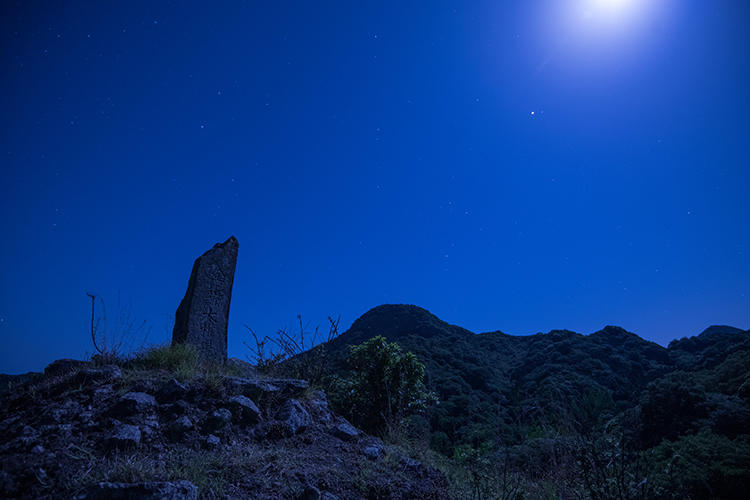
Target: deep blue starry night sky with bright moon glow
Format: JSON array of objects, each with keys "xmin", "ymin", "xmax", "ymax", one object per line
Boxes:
[{"xmin": 0, "ymin": 0, "xmax": 750, "ymax": 373}]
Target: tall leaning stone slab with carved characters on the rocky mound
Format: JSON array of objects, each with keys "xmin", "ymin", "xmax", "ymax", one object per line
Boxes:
[{"xmin": 172, "ymin": 236, "xmax": 240, "ymax": 363}]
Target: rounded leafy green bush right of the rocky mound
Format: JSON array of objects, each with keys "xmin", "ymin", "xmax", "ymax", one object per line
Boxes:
[{"xmin": 329, "ymin": 336, "xmax": 433, "ymax": 438}]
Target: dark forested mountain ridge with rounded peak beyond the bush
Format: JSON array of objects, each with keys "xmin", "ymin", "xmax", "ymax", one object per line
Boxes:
[{"xmin": 329, "ymin": 305, "xmax": 750, "ymax": 464}]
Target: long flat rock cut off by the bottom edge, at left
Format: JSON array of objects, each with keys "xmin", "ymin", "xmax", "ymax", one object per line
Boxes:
[{"xmin": 84, "ymin": 480, "xmax": 198, "ymax": 500}]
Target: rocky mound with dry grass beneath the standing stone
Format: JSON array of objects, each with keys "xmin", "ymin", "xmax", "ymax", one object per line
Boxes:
[{"xmin": 0, "ymin": 352, "xmax": 446, "ymax": 500}]
